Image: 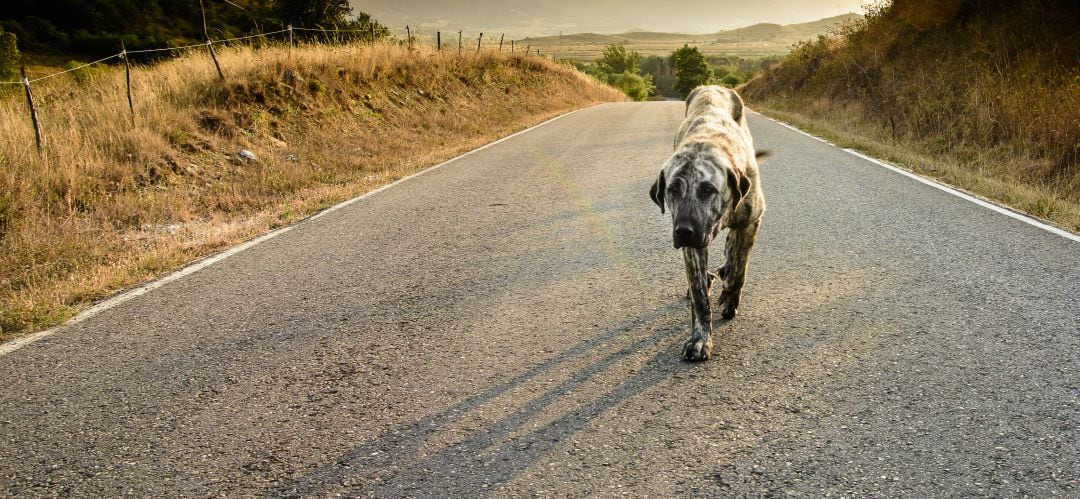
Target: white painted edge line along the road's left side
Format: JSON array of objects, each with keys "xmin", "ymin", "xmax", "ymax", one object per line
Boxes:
[{"xmin": 0, "ymin": 103, "xmax": 604, "ymax": 356}]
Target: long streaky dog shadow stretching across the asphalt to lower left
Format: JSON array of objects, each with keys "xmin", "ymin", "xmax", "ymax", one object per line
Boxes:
[{"xmin": 268, "ymin": 299, "xmax": 693, "ymax": 497}]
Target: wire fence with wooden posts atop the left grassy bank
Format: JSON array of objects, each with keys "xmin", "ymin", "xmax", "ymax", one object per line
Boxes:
[{"xmin": 0, "ymin": 25, "xmax": 554, "ymax": 153}]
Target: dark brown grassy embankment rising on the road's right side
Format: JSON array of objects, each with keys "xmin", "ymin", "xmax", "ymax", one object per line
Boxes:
[{"xmin": 743, "ymin": 0, "xmax": 1080, "ymax": 232}]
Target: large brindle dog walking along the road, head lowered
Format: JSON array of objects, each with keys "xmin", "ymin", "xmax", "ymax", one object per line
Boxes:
[{"xmin": 649, "ymin": 85, "xmax": 765, "ymax": 361}]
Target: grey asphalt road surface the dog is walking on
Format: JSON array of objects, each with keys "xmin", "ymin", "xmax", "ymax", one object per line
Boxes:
[{"xmin": 0, "ymin": 103, "xmax": 1080, "ymax": 497}]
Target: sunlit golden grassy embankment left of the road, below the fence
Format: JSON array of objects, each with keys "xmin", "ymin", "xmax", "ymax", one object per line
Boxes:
[{"xmin": 0, "ymin": 41, "xmax": 624, "ymax": 339}]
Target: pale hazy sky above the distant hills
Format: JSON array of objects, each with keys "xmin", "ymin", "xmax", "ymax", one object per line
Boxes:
[{"xmin": 350, "ymin": 0, "xmax": 865, "ymax": 37}]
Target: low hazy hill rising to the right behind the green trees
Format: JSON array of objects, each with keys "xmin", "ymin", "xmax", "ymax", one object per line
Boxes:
[{"xmin": 515, "ymin": 14, "xmax": 863, "ymax": 60}]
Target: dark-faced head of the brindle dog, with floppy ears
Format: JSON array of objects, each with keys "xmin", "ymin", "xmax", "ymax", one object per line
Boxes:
[{"xmin": 649, "ymin": 143, "xmax": 760, "ymax": 248}]
